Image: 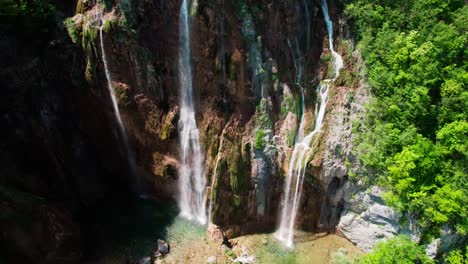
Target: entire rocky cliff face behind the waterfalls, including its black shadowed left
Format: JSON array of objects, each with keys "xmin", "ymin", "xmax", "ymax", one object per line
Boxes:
[{"xmin": 0, "ymin": 0, "xmax": 376, "ymax": 259}]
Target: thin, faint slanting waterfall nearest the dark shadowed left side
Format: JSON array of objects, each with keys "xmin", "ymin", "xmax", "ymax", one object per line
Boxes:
[{"xmin": 99, "ymin": 24, "xmax": 140, "ymax": 193}]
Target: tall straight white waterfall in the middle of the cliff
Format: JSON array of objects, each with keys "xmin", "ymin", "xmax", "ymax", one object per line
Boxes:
[{"xmin": 178, "ymin": 0, "xmax": 207, "ymax": 224}]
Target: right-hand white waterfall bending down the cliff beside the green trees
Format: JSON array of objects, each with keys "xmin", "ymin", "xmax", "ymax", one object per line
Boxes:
[{"xmin": 275, "ymin": 0, "xmax": 343, "ymax": 247}]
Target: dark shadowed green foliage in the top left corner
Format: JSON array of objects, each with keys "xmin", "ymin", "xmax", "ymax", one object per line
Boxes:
[{"xmin": 0, "ymin": 0, "xmax": 56, "ymax": 36}]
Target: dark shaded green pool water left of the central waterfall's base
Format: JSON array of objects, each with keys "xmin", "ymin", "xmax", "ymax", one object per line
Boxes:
[{"xmin": 82, "ymin": 197, "xmax": 179, "ymax": 263}]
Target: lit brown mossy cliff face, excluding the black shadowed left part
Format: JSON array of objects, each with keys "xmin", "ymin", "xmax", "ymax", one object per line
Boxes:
[{"xmin": 66, "ymin": 0, "xmax": 353, "ymax": 236}]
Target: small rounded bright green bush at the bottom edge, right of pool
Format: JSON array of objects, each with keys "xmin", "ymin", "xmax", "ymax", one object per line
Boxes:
[{"xmin": 357, "ymin": 236, "xmax": 434, "ymax": 264}]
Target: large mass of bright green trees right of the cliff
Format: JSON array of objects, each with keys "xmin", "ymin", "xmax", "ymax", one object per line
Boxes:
[{"xmin": 346, "ymin": 0, "xmax": 468, "ymax": 250}]
